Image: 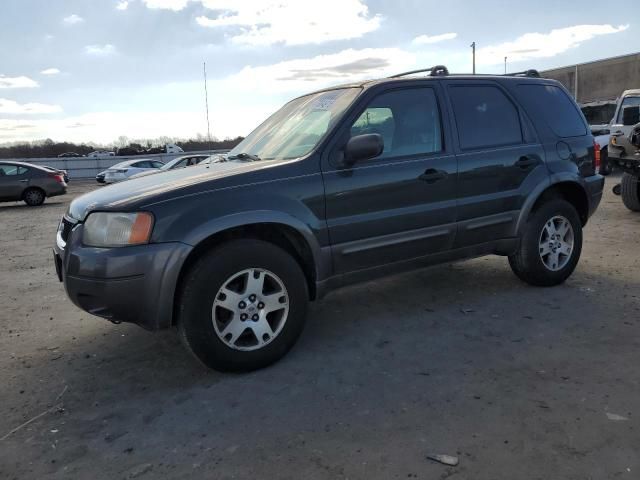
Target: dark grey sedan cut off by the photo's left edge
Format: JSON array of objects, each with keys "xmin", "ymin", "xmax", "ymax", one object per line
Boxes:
[{"xmin": 0, "ymin": 161, "xmax": 67, "ymax": 207}]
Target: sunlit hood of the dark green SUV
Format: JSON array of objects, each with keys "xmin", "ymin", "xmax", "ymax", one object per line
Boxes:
[{"xmin": 67, "ymin": 161, "xmax": 278, "ymax": 221}]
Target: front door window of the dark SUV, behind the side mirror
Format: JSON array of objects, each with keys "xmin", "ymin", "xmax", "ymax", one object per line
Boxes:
[{"xmin": 351, "ymin": 88, "xmax": 442, "ymax": 158}]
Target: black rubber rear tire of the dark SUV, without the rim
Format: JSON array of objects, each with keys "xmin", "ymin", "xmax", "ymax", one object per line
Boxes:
[{"xmin": 509, "ymin": 198, "xmax": 582, "ymax": 287}]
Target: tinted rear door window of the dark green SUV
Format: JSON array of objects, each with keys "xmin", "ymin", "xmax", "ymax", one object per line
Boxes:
[{"xmin": 449, "ymin": 85, "xmax": 522, "ymax": 149}]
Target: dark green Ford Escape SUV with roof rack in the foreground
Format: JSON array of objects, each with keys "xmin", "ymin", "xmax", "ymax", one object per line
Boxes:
[{"xmin": 54, "ymin": 67, "xmax": 604, "ymax": 371}]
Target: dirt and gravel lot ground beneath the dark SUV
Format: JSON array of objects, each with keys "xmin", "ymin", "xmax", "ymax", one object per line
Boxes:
[{"xmin": 0, "ymin": 178, "xmax": 640, "ymax": 480}]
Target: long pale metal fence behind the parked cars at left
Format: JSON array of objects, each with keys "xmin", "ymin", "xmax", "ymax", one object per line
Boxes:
[{"xmin": 5, "ymin": 150, "xmax": 228, "ymax": 179}]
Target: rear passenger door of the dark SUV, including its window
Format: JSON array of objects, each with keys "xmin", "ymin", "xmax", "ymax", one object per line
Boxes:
[{"xmin": 443, "ymin": 80, "xmax": 548, "ymax": 248}]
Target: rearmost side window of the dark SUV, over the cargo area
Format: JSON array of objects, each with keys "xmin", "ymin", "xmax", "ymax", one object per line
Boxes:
[{"xmin": 518, "ymin": 84, "xmax": 587, "ymax": 138}]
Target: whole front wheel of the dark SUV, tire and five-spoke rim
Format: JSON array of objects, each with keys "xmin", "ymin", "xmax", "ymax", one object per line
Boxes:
[{"xmin": 178, "ymin": 240, "xmax": 309, "ymax": 371}]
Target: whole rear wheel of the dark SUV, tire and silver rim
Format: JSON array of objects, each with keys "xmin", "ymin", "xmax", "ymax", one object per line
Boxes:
[{"xmin": 509, "ymin": 199, "xmax": 582, "ymax": 287}]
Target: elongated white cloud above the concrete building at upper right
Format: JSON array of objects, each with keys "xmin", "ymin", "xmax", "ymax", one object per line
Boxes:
[{"xmin": 477, "ymin": 24, "xmax": 629, "ymax": 65}]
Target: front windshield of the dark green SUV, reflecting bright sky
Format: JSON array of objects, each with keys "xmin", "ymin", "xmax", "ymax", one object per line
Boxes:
[{"xmin": 228, "ymin": 88, "xmax": 360, "ymax": 160}]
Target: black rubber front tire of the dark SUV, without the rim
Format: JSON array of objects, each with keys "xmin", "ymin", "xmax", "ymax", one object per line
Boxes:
[{"xmin": 177, "ymin": 239, "xmax": 309, "ymax": 372}]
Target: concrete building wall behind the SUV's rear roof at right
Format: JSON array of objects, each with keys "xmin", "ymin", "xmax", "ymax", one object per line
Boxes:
[{"xmin": 540, "ymin": 52, "xmax": 640, "ymax": 104}]
